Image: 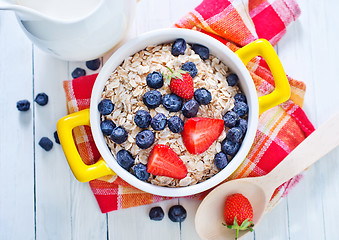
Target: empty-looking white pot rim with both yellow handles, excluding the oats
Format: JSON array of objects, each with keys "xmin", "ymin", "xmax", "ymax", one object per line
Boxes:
[{"xmin": 57, "ymin": 29, "xmax": 290, "ymax": 197}]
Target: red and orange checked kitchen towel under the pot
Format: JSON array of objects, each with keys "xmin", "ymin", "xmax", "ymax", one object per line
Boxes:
[{"xmin": 64, "ymin": 0, "xmax": 314, "ymax": 213}]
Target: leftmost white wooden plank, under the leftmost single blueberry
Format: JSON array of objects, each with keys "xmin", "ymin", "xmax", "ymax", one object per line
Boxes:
[{"xmin": 0, "ymin": 11, "xmax": 35, "ymax": 239}]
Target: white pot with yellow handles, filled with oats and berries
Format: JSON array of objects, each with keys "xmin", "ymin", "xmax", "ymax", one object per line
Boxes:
[{"xmin": 57, "ymin": 29, "xmax": 290, "ymax": 197}]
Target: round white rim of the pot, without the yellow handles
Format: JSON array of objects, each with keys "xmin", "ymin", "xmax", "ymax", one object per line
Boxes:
[{"xmin": 90, "ymin": 28, "xmax": 259, "ymax": 197}]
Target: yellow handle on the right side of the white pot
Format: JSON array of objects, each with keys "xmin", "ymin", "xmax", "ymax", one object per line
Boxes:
[{"xmin": 235, "ymin": 39, "xmax": 291, "ymax": 114}]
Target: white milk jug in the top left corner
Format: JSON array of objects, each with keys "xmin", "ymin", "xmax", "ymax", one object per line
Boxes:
[{"xmin": 0, "ymin": 0, "xmax": 136, "ymax": 61}]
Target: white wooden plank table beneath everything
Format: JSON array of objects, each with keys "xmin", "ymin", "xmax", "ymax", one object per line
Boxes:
[{"xmin": 0, "ymin": 0, "xmax": 339, "ymax": 240}]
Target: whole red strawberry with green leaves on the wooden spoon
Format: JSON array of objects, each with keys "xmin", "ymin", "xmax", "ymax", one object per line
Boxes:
[{"xmin": 224, "ymin": 193, "xmax": 254, "ymax": 239}]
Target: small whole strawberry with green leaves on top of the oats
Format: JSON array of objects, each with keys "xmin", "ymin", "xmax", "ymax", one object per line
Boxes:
[{"xmin": 165, "ymin": 68, "xmax": 194, "ymax": 99}]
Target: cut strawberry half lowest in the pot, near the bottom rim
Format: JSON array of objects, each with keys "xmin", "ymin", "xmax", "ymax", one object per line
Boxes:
[{"xmin": 147, "ymin": 144, "xmax": 187, "ymax": 179}]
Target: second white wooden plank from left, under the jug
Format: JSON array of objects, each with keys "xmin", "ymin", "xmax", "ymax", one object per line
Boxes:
[{"xmin": 34, "ymin": 47, "xmax": 72, "ymax": 239}]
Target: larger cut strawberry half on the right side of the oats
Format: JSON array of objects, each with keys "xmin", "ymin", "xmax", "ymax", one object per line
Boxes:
[{"xmin": 182, "ymin": 117, "xmax": 224, "ymax": 154}]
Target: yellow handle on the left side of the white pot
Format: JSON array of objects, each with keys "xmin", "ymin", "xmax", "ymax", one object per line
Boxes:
[{"xmin": 57, "ymin": 109, "xmax": 116, "ymax": 182}]
